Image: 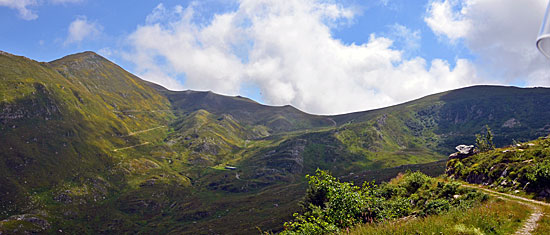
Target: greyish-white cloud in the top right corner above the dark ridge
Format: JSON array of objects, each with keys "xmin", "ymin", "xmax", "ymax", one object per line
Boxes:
[{"xmin": 425, "ymin": 0, "xmax": 550, "ymax": 86}]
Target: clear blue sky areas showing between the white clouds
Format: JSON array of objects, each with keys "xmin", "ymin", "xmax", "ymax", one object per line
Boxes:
[{"xmin": 0, "ymin": 0, "xmax": 471, "ymax": 69}]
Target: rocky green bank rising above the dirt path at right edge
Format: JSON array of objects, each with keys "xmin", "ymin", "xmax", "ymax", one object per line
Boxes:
[{"xmin": 446, "ymin": 135, "xmax": 550, "ymax": 198}]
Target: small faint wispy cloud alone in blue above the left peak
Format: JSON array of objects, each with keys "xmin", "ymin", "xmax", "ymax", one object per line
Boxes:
[{"xmin": 65, "ymin": 16, "xmax": 103, "ymax": 44}]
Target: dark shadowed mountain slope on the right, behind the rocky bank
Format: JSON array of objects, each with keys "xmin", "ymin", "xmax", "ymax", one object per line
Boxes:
[{"xmin": 331, "ymin": 86, "xmax": 550, "ymax": 151}]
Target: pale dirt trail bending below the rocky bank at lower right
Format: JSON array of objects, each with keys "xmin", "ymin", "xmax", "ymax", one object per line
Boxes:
[{"xmin": 462, "ymin": 184, "xmax": 550, "ymax": 234}]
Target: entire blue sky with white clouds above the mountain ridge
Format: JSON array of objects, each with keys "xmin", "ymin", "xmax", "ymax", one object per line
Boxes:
[{"xmin": 0, "ymin": 0, "xmax": 550, "ymax": 114}]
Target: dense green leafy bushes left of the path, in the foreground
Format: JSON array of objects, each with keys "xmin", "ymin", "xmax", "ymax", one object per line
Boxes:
[{"xmin": 282, "ymin": 170, "xmax": 488, "ymax": 234}]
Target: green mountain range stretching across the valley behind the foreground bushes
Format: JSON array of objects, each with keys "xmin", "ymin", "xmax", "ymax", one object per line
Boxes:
[{"xmin": 0, "ymin": 52, "xmax": 550, "ymax": 234}]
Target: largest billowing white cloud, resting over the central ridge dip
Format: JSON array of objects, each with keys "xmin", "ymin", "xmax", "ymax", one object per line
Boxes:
[{"xmin": 125, "ymin": 0, "xmax": 478, "ymax": 114}]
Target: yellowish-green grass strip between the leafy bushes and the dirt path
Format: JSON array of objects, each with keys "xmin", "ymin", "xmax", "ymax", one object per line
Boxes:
[{"xmin": 348, "ymin": 198, "xmax": 532, "ymax": 235}]
